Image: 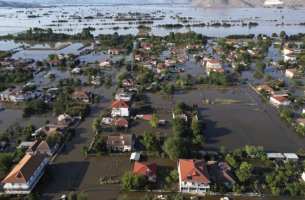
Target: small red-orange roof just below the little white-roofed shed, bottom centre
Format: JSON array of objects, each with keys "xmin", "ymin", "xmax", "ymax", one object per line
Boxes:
[{"xmin": 133, "ymin": 162, "xmax": 157, "ymax": 177}]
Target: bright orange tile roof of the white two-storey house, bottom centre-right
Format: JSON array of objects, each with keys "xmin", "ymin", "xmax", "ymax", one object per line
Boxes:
[{"xmin": 179, "ymin": 159, "xmax": 210, "ymax": 183}]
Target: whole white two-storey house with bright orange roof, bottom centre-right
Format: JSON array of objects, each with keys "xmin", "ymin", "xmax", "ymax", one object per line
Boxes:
[{"xmin": 178, "ymin": 159, "xmax": 211, "ymax": 193}]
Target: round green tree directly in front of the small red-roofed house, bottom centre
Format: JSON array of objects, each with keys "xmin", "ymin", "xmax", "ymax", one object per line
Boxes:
[{"xmin": 122, "ymin": 172, "xmax": 147, "ymax": 190}]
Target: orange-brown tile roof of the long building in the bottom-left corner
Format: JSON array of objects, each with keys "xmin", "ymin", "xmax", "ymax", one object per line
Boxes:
[{"xmin": 2, "ymin": 154, "xmax": 48, "ymax": 183}]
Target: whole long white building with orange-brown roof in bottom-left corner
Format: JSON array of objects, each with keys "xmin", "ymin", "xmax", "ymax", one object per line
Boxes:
[{"xmin": 2, "ymin": 154, "xmax": 49, "ymax": 194}]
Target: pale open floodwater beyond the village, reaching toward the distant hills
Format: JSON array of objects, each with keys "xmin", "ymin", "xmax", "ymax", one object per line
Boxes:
[{"xmin": 0, "ymin": 4, "xmax": 305, "ymax": 36}]
